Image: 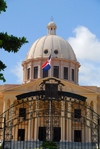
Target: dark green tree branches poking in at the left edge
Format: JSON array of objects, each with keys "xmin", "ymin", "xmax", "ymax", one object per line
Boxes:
[{"xmin": 0, "ymin": 0, "xmax": 28, "ymax": 82}]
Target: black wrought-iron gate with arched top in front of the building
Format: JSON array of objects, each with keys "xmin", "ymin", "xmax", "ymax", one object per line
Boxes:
[{"xmin": 1, "ymin": 80, "xmax": 100, "ymax": 149}]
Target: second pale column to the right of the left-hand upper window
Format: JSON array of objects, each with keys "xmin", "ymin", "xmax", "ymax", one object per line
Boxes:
[{"xmin": 34, "ymin": 99, "xmax": 39, "ymax": 141}]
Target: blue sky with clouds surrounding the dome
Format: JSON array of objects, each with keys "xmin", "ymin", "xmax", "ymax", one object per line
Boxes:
[{"xmin": 0, "ymin": 0, "xmax": 100, "ymax": 86}]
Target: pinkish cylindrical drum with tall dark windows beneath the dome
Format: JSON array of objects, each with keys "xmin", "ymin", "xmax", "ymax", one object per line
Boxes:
[{"xmin": 22, "ymin": 58, "xmax": 80, "ymax": 84}]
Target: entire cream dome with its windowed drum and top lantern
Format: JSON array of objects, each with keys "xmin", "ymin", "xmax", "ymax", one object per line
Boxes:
[{"xmin": 22, "ymin": 22, "xmax": 80, "ymax": 84}]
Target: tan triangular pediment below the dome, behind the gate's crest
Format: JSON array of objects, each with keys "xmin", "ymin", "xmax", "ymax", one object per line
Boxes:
[{"xmin": 3, "ymin": 77, "xmax": 99, "ymax": 94}]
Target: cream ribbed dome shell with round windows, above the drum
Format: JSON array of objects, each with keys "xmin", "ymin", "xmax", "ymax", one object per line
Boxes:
[{"xmin": 25, "ymin": 35, "xmax": 77, "ymax": 62}]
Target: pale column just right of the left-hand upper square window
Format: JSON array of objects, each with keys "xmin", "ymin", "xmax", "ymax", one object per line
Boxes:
[{"xmin": 28, "ymin": 98, "xmax": 33, "ymax": 141}]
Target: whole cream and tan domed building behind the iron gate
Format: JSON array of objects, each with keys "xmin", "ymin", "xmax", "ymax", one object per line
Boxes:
[{"xmin": 0, "ymin": 22, "xmax": 100, "ymax": 147}]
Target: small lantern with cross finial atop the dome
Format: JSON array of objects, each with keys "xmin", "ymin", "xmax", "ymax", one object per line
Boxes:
[{"xmin": 47, "ymin": 18, "xmax": 57, "ymax": 35}]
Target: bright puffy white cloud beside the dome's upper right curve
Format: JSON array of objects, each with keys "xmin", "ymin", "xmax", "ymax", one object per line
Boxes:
[{"xmin": 68, "ymin": 26, "xmax": 100, "ymax": 62}]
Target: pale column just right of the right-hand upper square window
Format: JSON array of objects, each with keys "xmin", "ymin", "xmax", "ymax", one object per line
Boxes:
[{"xmin": 86, "ymin": 101, "xmax": 91, "ymax": 143}]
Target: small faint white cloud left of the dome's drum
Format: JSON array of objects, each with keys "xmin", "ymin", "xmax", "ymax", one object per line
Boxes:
[{"xmin": 11, "ymin": 61, "xmax": 23, "ymax": 83}]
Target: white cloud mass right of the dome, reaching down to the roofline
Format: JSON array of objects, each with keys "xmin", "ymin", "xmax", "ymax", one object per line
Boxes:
[{"xmin": 68, "ymin": 26, "xmax": 100, "ymax": 86}]
